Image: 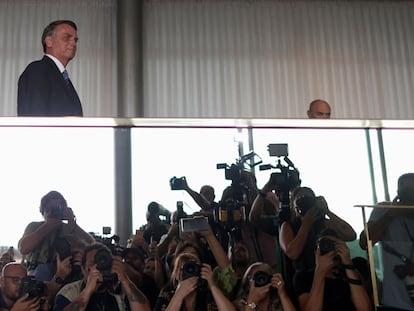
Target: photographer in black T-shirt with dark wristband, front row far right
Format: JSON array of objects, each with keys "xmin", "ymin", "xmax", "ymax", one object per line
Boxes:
[{"xmin": 293, "ymin": 229, "xmax": 373, "ymax": 311}]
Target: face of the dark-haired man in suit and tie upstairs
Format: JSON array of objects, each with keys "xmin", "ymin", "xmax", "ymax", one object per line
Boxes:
[{"xmin": 45, "ymin": 24, "xmax": 78, "ymax": 66}]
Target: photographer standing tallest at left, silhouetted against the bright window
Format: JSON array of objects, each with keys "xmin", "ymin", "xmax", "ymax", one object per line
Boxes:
[{"xmin": 18, "ymin": 191, "xmax": 94, "ymax": 281}]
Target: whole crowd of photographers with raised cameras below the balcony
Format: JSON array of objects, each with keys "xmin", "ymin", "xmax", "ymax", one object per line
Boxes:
[{"xmin": 0, "ymin": 155, "xmax": 414, "ymax": 311}]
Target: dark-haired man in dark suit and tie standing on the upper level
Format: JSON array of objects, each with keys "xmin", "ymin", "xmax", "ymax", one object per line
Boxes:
[{"xmin": 17, "ymin": 20, "xmax": 83, "ymax": 117}]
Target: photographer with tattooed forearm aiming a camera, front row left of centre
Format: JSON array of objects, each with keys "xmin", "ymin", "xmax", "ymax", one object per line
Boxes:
[{"xmin": 54, "ymin": 243, "xmax": 151, "ymax": 311}]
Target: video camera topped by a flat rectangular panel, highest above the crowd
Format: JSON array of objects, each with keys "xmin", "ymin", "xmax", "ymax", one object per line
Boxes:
[{"xmin": 259, "ymin": 144, "xmax": 301, "ymax": 222}]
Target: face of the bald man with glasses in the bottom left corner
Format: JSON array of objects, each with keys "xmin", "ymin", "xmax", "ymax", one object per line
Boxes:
[{"xmin": 0, "ymin": 264, "xmax": 27, "ymax": 301}]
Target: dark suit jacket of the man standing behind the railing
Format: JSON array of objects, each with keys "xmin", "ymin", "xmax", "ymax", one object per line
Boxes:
[{"xmin": 17, "ymin": 56, "xmax": 83, "ymax": 117}]
